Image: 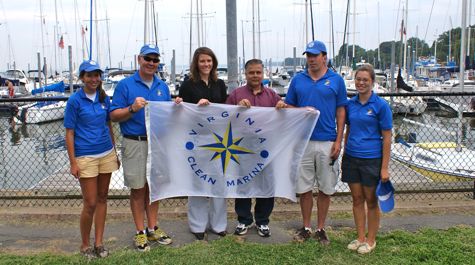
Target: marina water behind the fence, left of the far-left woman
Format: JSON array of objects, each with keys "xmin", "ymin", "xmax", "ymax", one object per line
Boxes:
[{"xmin": 0, "ymin": 118, "xmax": 69, "ymax": 190}]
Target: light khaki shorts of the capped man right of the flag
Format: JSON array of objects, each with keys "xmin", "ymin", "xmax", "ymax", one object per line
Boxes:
[{"xmin": 296, "ymin": 141, "xmax": 340, "ymax": 195}]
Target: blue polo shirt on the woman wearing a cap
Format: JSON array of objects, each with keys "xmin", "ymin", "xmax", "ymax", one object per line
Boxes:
[{"xmin": 64, "ymin": 89, "xmax": 113, "ymax": 157}]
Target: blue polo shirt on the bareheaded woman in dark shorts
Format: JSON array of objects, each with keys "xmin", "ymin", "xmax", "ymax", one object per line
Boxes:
[{"xmin": 345, "ymin": 92, "xmax": 393, "ymax": 158}]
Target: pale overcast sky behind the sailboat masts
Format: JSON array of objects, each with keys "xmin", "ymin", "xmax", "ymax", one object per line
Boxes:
[{"xmin": 0, "ymin": 0, "xmax": 468, "ymax": 72}]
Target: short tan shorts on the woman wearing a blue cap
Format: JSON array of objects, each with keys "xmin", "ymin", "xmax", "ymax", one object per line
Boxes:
[{"xmin": 76, "ymin": 150, "xmax": 119, "ymax": 178}]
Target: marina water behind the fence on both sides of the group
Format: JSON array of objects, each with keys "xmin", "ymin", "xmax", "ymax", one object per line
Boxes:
[{"xmin": 0, "ymin": 111, "xmax": 475, "ymax": 190}]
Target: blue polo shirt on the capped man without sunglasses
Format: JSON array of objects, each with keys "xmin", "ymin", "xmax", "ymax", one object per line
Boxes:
[{"xmin": 285, "ymin": 69, "xmax": 348, "ymax": 141}]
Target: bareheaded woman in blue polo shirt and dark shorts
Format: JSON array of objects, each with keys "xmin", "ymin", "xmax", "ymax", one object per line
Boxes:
[{"xmin": 341, "ymin": 64, "xmax": 392, "ymax": 254}]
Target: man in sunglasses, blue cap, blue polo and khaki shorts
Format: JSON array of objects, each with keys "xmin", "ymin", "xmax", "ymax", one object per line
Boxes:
[{"xmin": 110, "ymin": 44, "xmax": 172, "ymax": 251}]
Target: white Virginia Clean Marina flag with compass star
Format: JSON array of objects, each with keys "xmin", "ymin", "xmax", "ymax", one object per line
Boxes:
[{"xmin": 146, "ymin": 102, "xmax": 319, "ymax": 201}]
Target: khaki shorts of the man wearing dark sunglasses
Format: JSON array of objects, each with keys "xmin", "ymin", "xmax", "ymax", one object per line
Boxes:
[{"xmin": 121, "ymin": 138, "xmax": 148, "ymax": 189}]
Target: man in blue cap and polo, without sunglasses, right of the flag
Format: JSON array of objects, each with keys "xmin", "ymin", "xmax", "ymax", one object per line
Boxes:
[{"xmin": 285, "ymin": 38, "xmax": 347, "ymax": 245}]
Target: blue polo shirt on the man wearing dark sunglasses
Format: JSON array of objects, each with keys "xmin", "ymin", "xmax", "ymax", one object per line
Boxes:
[{"xmin": 110, "ymin": 72, "xmax": 171, "ymax": 136}]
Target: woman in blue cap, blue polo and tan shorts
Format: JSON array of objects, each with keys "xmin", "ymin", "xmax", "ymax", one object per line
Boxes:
[{"xmin": 64, "ymin": 61, "xmax": 119, "ymax": 258}]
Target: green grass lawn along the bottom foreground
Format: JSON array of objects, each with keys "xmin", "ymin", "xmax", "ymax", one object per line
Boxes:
[{"xmin": 0, "ymin": 226, "xmax": 475, "ymax": 265}]
